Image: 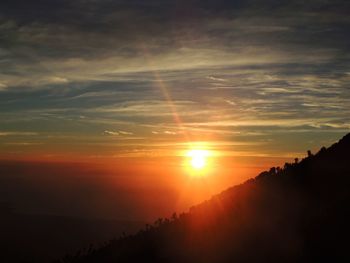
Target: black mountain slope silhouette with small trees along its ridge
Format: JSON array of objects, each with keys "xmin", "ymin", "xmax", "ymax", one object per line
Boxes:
[{"xmin": 59, "ymin": 134, "xmax": 350, "ymax": 263}]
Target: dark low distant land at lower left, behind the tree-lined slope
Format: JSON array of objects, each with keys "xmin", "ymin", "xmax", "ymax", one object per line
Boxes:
[{"xmin": 0, "ymin": 213, "xmax": 144, "ymax": 263}]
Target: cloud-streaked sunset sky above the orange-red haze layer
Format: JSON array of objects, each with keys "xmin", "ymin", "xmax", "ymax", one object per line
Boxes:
[{"xmin": 0, "ymin": 0, "xmax": 350, "ymax": 221}]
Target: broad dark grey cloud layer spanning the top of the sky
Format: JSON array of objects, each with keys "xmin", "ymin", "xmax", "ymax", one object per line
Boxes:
[{"xmin": 0, "ymin": 1, "xmax": 350, "ymax": 87}]
